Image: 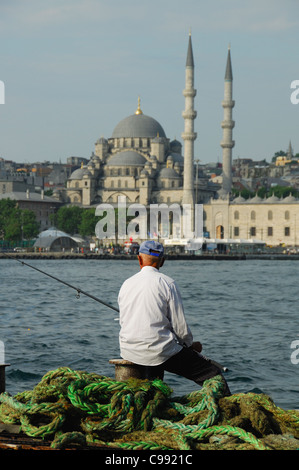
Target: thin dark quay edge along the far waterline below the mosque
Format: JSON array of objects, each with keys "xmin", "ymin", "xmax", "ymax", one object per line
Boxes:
[{"xmin": 0, "ymin": 252, "xmax": 299, "ymax": 261}]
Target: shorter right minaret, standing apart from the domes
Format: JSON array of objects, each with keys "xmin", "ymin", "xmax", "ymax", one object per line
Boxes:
[{"xmin": 220, "ymin": 47, "xmax": 235, "ymax": 195}]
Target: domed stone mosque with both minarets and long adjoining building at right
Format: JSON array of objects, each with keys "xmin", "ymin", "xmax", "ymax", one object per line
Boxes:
[{"xmin": 66, "ymin": 34, "xmax": 299, "ymax": 246}]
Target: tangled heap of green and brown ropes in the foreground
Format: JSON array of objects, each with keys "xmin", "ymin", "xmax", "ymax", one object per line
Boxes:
[{"xmin": 0, "ymin": 367, "xmax": 299, "ymax": 450}]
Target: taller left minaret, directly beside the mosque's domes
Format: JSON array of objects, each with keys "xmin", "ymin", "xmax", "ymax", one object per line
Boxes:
[{"xmin": 182, "ymin": 33, "xmax": 197, "ymax": 210}]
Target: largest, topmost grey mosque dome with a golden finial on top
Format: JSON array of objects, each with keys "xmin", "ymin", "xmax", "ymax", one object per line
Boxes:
[{"xmin": 112, "ymin": 101, "xmax": 166, "ymax": 139}]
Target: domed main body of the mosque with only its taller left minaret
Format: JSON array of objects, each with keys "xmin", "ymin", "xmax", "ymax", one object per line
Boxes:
[{"xmin": 67, "ymin": 36, "xmax": 219, "ymax": 211}]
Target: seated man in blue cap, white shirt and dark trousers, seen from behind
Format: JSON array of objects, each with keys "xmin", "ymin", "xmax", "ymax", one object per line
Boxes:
[{"xmin": 118, "ymin": 240, "xmax": 230, "ymax": 395}]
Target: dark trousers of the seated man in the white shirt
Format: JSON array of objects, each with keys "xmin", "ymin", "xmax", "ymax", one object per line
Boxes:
[{"xmin": 143, "ymin": 348, "xmax": 231, "ymax": 396}]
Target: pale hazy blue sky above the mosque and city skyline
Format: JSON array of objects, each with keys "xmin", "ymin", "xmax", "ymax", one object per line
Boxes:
[{"xmin": 0, "ymin": 0, "xmax": 299, "ymax": 163}]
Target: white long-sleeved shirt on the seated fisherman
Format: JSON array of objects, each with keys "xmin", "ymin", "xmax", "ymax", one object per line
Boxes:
[{"xmin": 118, "ymin": 266, "xmax": 193, "ymax": 366}]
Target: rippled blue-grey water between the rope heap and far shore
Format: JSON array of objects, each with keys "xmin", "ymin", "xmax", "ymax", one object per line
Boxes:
[{"xmin": 0, "ymin": 259, "xmax": 299, "ymax": 409}]
